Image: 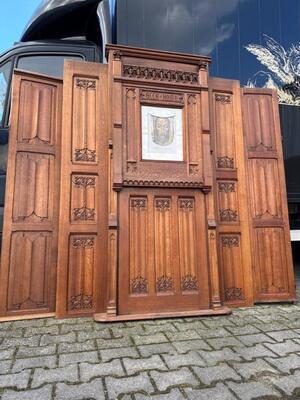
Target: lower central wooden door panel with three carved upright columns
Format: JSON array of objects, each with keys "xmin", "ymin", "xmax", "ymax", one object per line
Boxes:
[{"xmin": 119, "ymin": 189, "xmax": 209, "ymax": 314}]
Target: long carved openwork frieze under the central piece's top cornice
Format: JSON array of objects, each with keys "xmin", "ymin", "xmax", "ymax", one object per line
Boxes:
[{"xmin": 123, "ymin": 64, "xmax": 199, "ymax": 85}]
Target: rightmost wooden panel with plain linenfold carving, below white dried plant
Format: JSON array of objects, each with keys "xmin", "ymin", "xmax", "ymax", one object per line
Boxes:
[{"xmin": 242, "ymin": 89, "xmax": 295, "ymax": 302}]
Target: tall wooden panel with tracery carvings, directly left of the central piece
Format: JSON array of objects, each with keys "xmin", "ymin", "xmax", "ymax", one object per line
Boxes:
[{"xmin": 57, "ymin": 61, "xmax": 108, "ymax": 317}]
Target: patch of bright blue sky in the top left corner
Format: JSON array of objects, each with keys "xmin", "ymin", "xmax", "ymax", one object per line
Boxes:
[{"xmin": 0, "ymin": 0, "xmax": 41, "ymax": 54}]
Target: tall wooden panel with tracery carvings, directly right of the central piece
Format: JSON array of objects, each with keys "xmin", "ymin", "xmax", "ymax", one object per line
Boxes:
[{"xmin": 210, "ymin": 78, "xmax": 253, "ymax": 307}]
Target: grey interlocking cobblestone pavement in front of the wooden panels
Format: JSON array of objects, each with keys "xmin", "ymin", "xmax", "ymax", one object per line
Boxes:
[{"xmin": 0, "ymin": 268, "xmax": 300, "ymax": 400}]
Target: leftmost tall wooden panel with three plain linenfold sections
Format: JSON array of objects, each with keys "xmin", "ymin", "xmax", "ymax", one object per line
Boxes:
[{"xmin": 0, "ymin": 71, "xmax": 62, "ymax": 316}]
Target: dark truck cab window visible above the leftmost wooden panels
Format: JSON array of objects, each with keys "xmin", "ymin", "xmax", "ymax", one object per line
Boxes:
[{"xmin": 17, "ymin": 54, "xmax": 84, "ymax": 78}]
